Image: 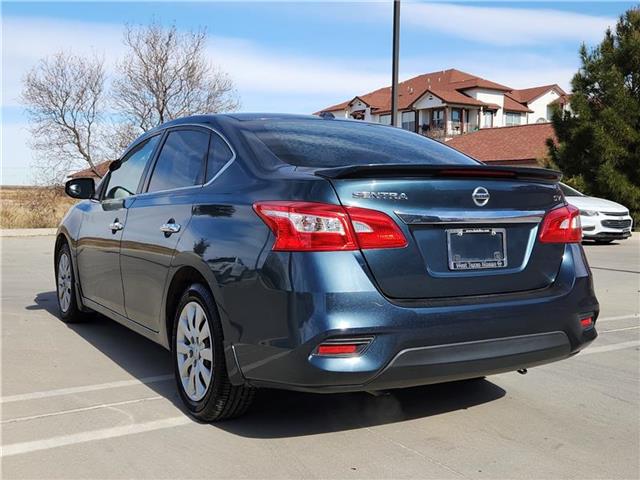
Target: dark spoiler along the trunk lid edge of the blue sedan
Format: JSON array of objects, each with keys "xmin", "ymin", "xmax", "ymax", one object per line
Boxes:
[{"xmin": 314, "ymin": 163, "xmax": 562, "ymax": 183}]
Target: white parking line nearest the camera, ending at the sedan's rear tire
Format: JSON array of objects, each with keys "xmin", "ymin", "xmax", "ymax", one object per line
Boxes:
[{"xmin": 0, "ymin": 415, "xmax": 195, "ymax": 457}]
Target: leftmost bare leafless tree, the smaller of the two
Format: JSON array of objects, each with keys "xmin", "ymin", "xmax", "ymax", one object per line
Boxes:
[{"xmin": 22, "ymin": 53, "xmax": 105, "ymax": 183}]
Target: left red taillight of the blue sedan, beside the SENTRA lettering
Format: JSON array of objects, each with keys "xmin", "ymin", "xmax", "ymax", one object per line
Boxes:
[{"xmin": 253, "ymin": 202, "xmax": 407, "ymax": 252}]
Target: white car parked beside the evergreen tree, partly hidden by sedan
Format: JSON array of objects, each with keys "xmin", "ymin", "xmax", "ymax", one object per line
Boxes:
[{"xmin": 560, "ymin": 183, "xmax": 633, "ymax": 243}]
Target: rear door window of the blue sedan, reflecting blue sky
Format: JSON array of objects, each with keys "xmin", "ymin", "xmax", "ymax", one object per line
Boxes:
[{"xmin": 147, "ymin": 130, "xmax": 209, "ymax": 192}]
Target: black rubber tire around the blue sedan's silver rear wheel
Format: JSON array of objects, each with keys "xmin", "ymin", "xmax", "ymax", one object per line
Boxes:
[{"xmin": 171, "ymin": 283, "xmax": 255, "ymax": 422}]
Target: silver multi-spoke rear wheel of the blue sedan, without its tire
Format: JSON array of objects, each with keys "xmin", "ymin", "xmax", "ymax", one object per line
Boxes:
[{"xmin": 176, "ymin": 301, "xmax": 213, "ymax": 402}]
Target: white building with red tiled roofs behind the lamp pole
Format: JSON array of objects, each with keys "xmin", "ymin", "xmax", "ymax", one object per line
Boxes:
[{"xmin": 316, "ymin": 68, "xmax": 567, "ymax": 140}]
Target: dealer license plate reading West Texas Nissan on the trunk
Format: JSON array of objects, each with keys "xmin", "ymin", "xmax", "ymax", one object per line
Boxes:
[{"xmin": 447, "ymin": 228, "xmax": 507, "ymax": 270}]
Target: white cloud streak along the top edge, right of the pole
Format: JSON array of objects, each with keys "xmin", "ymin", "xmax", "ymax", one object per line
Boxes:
[{"xmin": 400, "ymin": 3, "xmax": 615, "ymax": 46}]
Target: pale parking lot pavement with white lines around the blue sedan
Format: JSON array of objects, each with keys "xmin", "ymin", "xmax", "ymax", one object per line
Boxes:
[{"xmin": 0, "ymin": 234, "xmax": 640, "ymax": 479}]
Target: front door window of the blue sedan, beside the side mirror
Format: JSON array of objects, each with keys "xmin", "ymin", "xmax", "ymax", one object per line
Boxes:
[{"xmin": 104, "ymin": 135, "xmax": 160, "ymax": 199}]
